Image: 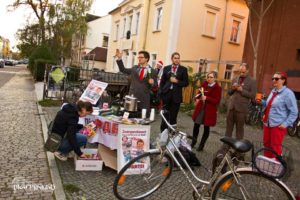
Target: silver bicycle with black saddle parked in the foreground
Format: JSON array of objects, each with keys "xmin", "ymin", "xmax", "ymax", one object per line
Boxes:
[{"xmin": 113, "ymin": 111, "xmax": 295, "ymax": 200}]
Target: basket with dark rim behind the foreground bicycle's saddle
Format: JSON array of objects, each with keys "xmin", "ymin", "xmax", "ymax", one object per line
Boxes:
[{"xmin": 252, "ymin": 148, "xmax": 287, "ymax": 178}]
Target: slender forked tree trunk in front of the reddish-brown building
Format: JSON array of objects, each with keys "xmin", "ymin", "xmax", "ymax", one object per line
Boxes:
[{"xmin": 245, "ymin": 0, "xmax": 274, "ymax": 78}]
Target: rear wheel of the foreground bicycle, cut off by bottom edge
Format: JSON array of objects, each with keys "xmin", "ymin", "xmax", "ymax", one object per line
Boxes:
[{"xmin": 212, "ymin": 169, "xmax": 294, "ymax": 200}]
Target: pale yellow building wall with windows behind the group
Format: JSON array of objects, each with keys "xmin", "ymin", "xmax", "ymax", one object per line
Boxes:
[{"xmin": 106, "ymin": 0, "xmax": 248, "ymax": 78}]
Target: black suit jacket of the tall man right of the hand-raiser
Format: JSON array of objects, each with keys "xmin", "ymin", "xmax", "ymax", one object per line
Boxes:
[{"xmin": 160, "ymin": 65, "xmax": 189, "ymax": 103}]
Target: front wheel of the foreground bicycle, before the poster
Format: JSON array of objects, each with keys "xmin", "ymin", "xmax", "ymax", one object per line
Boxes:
[{"xmin": 113, "ymin": 151, "xmax": 173, "ymax": 200}]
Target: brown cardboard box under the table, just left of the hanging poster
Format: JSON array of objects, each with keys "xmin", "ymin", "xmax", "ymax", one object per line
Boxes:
[{"xmin": 98, "ymin": 144, "xmax": 117, "ymax": 170}]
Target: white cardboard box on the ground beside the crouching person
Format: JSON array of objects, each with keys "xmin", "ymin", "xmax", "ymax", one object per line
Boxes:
[{"xmin": 74, "ymin": 149, "xmax": 103, "ymax": 171}]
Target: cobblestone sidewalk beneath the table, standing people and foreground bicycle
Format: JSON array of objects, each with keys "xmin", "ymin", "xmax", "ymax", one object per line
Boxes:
[{"xmin": 43, "ymin": 104, "xmax": 300, "ymax": 200}]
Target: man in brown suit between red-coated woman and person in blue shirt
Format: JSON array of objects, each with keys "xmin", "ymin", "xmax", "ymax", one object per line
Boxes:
[{"xmin": 225, "ymin": 63, "xmax": 256, "ymax": 139}]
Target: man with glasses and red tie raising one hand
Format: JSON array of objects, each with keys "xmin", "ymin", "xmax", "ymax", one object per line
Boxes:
[{"xmin": 115, "ymin": 49, "xmax": 157, "ymax": 113}]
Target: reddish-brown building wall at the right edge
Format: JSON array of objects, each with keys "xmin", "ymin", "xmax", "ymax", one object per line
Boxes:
[{"xmin": 243, "ymin": 0, "xmax": 300, "ymax": 99}]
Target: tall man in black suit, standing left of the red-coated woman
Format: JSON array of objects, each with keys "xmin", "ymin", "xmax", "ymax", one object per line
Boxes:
[{"xmin": 160, "ymin": 52, "xmax": 189, "ymax": 131}]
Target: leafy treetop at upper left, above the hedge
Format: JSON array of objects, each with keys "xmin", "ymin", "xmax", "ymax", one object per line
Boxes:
[{"xmin": 11, "ymin": 0, "xmax": 93, "ymax": 59}]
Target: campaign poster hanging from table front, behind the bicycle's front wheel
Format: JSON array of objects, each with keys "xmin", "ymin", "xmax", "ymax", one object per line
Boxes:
[{"xmin": 118, "ymin": 124, "xmax": 150, "ymax": 174}]
